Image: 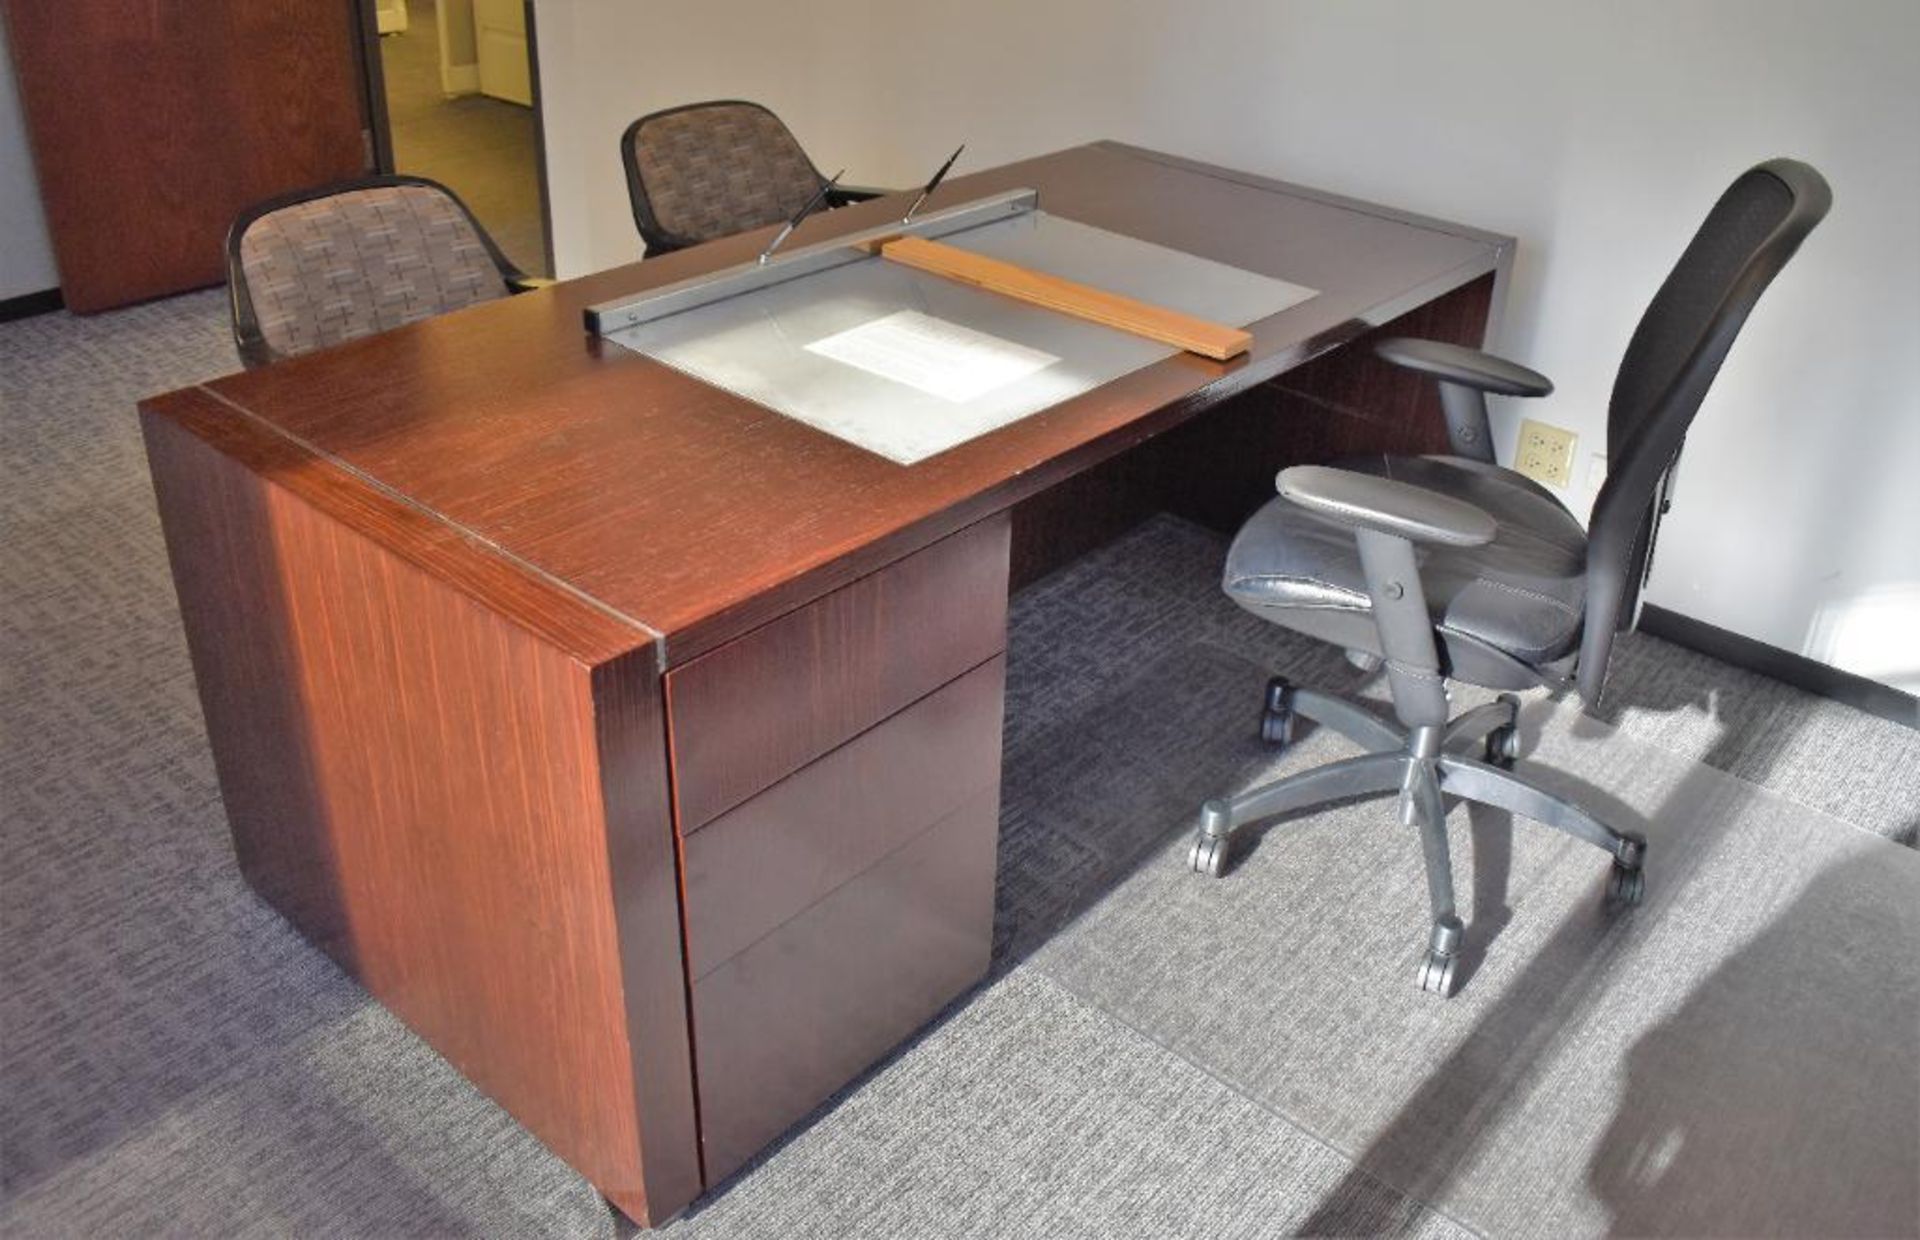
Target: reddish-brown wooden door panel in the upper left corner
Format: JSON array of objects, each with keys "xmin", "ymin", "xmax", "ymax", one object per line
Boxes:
[{"xmin": 6, "ymin": 0, "xmax": 365, "ymax": 313}]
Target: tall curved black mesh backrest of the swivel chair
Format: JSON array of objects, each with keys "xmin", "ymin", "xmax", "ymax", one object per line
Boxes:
[{"xmin": 1578, "ymin": 159, "xmax": 1834, "ymax": 701}]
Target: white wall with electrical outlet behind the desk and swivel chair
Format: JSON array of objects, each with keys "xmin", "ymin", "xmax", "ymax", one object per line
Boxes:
[{"xmin": 538, "ymin": 0, "xmax": 1920, "ymax": 691}]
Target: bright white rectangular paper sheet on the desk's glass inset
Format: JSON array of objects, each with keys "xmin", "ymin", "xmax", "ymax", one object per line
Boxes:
[{"xmin": 806, "ymin": 311, "xmax": 1060, "ymax": 405}]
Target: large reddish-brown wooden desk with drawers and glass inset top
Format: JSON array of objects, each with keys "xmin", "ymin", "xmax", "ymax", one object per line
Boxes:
[{"xmin": 142, "ymin": 144, "xmax": 1511, "ymax": 1221}]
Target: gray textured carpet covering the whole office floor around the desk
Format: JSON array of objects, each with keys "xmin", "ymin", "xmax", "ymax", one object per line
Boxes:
[{"xmin": 0, "ymin": 292, "xmax": 1920, "ymax": 1238}]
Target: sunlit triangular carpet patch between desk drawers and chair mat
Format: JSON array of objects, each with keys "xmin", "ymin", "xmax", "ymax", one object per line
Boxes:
[{"xmin": 662, "ymin": 969, "xmax": 1469, "ymax": 1240}]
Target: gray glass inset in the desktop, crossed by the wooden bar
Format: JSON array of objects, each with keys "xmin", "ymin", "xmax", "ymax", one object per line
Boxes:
[{"xmin": 607, "ymin": 211, "xmax": 1315, "ymax": 465}]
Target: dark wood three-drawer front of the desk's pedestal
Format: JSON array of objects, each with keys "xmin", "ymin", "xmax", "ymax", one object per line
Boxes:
[{"xmin": 666, "ymin": 513, "xmax": 1010, "ymax": 1182}]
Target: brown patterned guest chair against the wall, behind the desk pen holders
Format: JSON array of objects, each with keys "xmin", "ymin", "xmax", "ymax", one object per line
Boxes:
[{"xmin": 620, "ymin": 100, "xmax": 889, "ymax": 257}]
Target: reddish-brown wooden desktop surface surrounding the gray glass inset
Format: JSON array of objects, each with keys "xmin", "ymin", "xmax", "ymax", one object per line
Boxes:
[{"xmin": 146, "ymin": 144, "xmax": 1509, "ymax": 664}]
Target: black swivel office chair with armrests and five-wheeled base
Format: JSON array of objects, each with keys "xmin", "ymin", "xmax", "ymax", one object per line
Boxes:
[{"xmin": 1188, "ymin": 159, "xmax": 1832, "ymax": 996}]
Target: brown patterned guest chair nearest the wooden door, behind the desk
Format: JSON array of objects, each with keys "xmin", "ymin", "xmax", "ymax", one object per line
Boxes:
[{"xmin": 227, "ymin": 177, "xmax": 551, "ymax": 369}]
